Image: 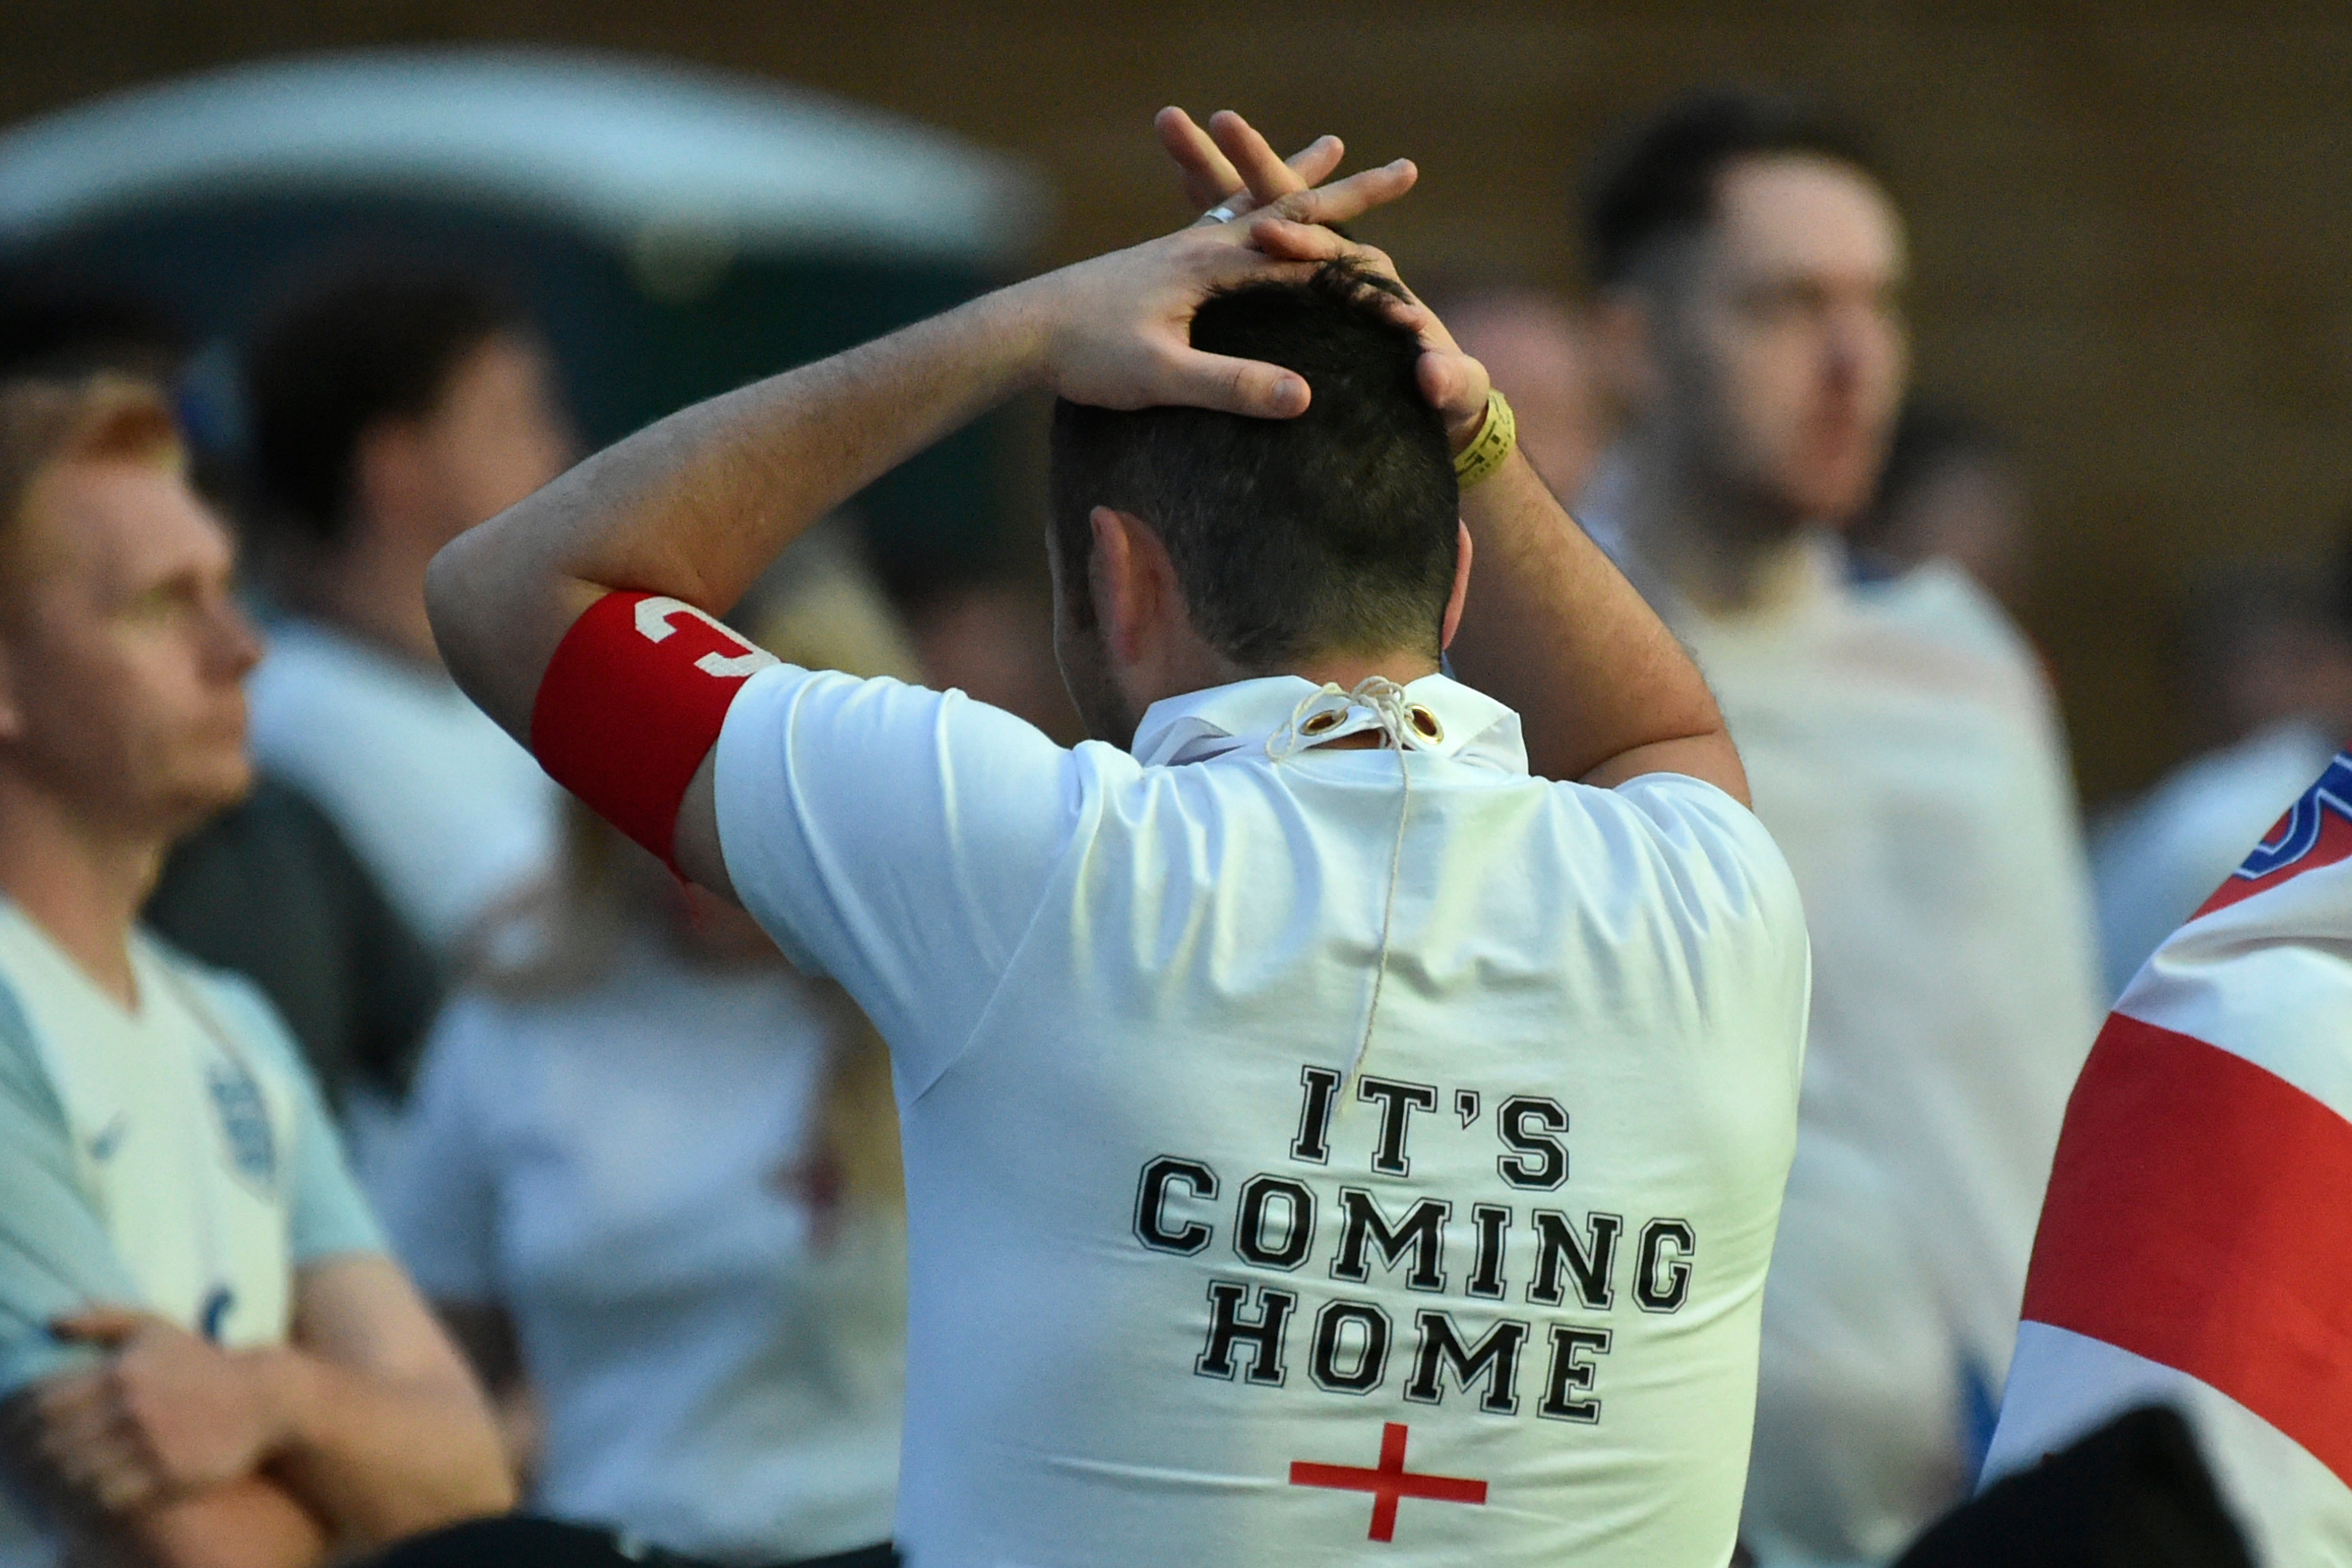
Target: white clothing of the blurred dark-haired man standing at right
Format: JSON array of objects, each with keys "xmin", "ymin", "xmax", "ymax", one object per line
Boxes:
[{"xmin": 1668, "ymin": 536, "xmax": 2098, "ymax": 1566}]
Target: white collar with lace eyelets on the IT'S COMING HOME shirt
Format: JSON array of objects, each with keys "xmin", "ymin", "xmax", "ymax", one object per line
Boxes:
[{"xmin": 1134, "ymin": 675, "xmax": 1526, "ymax": 773}]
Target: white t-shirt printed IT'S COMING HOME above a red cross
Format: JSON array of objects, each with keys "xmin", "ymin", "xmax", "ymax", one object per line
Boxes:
[{"xmin": 717, "ymin": 665, "xmax": 1806, "ymax": 1568}]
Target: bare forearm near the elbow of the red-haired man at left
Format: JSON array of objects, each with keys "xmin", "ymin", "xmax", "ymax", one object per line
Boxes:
[{"xmin": 254, "ymin": 1349, "xmax": 515, "ymax": 1549}]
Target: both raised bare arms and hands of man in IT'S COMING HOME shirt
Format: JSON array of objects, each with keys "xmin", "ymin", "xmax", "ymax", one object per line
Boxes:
[{"xmin": 426, "ymin": 110, "xmax": 1748, "ymax": 907}]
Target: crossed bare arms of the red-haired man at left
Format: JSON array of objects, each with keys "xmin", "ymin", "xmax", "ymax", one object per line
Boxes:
[{"xmin": 0, "ymin": 1256, "xmax": 513, "ymax": 1568}]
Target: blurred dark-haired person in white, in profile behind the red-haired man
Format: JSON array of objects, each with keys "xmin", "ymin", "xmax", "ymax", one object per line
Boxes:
[{"xmin": 245, "ymin": 270, "xmax": 574, "ymax": 957}]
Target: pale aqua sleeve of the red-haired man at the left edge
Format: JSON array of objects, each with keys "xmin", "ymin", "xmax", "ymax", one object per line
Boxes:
[{"xmin": 0, "ymin": 985, "xmax": 139, "ymax": 1399}]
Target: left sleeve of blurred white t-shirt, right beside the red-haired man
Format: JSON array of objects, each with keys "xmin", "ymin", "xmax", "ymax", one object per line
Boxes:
[{"xmin": 377, "ymin": 997, "xmax": 501, "ymax": 1302}]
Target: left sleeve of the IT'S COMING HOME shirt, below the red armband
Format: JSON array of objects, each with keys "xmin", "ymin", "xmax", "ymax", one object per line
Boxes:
[{"xmin": 715, "ymin": 665, "xmax": 1084, "ymax": 1100}]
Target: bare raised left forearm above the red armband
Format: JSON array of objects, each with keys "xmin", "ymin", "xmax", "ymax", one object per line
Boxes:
[{"xmin": 428, "ymin": 289, "xmax": 1042, "ymax": 738}]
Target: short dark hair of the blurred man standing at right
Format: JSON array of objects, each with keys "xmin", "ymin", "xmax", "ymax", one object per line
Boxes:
[{"xmin": 1583, "ymin": 87, "xmax": 1886, "ymax": 289}]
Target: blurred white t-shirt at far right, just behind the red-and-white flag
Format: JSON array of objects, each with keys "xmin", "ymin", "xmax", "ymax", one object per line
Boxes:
[{"xmin": 2091, "ymin": 720, "xmax": 2336, "ymax": 999}]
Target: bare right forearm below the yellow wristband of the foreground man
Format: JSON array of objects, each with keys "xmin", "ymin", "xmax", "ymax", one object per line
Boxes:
[{"xmin": 1451, "ymin": 451, "xmax": 1748, "ymax": 802}]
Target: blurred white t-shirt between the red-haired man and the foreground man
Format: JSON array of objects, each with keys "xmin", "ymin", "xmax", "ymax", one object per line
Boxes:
[{"xmin": 379, "ymin": 943, "xmax": 906, "ymax": 1563}]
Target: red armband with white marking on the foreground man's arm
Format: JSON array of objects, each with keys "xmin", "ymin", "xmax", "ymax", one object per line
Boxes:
[{"xmin": 532, "ymin": 592, "xmax": 776, "ymax": 870}]
